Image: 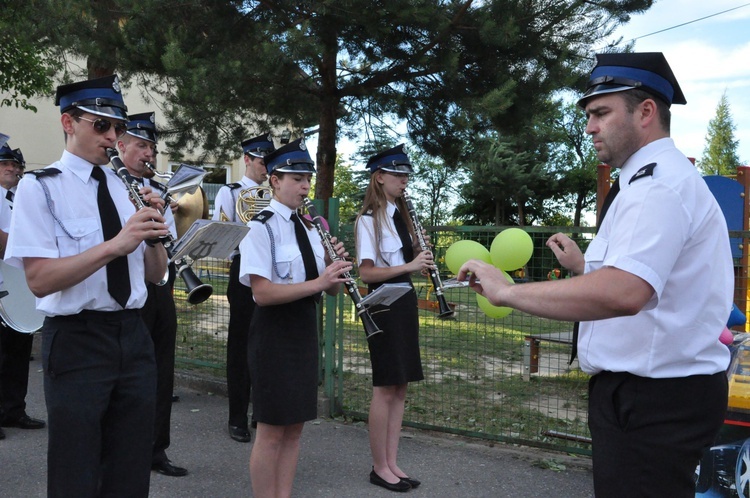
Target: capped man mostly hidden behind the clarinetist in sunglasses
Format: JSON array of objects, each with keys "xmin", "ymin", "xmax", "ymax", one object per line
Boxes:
[{"xmin": 117, "ymin": 112, "xmax": 188, "ymax": 477}]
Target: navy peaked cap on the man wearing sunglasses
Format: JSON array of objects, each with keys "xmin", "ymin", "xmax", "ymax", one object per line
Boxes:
[{"xmin": 55, "ymin": 74, "xmax": 128, "ymax": 121}]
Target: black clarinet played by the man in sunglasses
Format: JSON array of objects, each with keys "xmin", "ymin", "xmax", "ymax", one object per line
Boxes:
[{"xmin": 107, "ymin": 148, "xmax": 214, "ymax": 304}]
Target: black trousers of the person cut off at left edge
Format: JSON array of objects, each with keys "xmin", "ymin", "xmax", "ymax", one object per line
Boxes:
[{"xmin": 0, "ymin": 322, "xmax": 34, "ymax": 419}]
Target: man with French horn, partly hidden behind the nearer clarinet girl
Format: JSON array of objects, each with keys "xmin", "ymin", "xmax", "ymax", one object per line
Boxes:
[{"xmin": 213, "ymin": 133, "xmax": 274, "ymax": 443}]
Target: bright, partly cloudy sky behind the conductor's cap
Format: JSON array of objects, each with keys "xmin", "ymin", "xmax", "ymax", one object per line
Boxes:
[{"xmin": 604, "ymin": 0, "xmax": 750, "ymax": 166}]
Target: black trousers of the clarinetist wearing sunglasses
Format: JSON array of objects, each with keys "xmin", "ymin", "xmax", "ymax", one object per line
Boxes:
[{"xmin": 42, "ymin": 310, "xmax": 156, "ymax": 498}]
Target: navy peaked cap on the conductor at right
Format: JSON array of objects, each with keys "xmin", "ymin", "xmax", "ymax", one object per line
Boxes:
[{"xmin": 578, "ymin": 52, "xmax": 687, "ymax": 108}]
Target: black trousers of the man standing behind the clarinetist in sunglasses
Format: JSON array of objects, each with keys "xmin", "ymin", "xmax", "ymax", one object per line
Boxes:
[{"xmin": 141, "ymin": 268, "xmax": 177, "ymax": 463}]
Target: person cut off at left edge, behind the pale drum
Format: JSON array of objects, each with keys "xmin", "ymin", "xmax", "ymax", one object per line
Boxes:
[{"xmin": 0, "ymin": 144, "xmax": 46, "ymax": 438}]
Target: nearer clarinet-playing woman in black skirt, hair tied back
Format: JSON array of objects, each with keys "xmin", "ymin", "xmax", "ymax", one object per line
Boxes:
[{"xmin": 240, "ymin": 140, "xmax": 352, "ymax": 497}]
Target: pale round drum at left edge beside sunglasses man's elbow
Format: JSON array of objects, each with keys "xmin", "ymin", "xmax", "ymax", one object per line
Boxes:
[{"xmin": 0, "ymin": 260, "xmax": 44, "ymax": 334}]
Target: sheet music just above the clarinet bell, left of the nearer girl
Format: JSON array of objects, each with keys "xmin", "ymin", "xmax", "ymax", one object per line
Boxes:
[{"xmin": 170, "ymin": 220, "xmax": 250, "ymax": 262}]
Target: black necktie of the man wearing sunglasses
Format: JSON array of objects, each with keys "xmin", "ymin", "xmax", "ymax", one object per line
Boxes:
[{"xmin": 91, "ymin": 166, "xmax": 130, "ymax": 308}]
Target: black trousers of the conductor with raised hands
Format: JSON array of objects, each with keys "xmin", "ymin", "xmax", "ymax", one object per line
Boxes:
[{"xmin": 589, "ymin": 372, "xmax": 728, "ymax": 498}]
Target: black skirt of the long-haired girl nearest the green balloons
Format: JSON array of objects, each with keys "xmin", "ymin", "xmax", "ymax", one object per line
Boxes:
[{"xmin": 367, "ymin": 278, "xmax": 424, "ymax": 387}]
